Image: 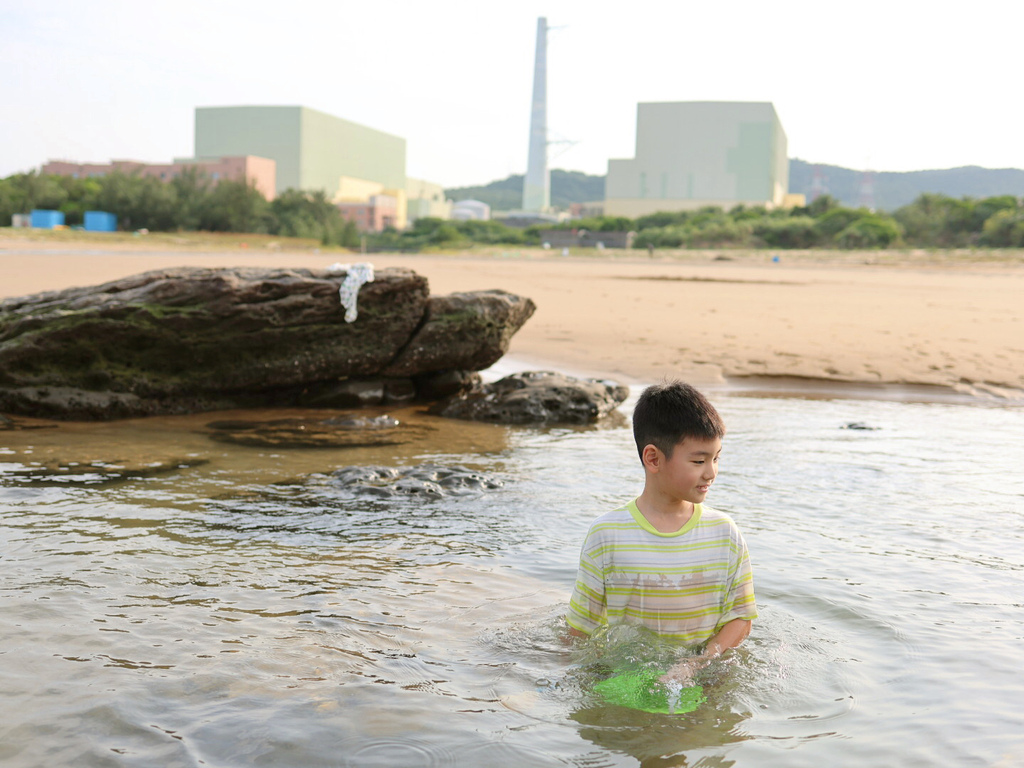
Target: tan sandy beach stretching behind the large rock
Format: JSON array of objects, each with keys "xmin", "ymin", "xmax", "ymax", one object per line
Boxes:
[{"xmin": 0, "ymin": 233, "xmax": 1024, "ymax": 404}]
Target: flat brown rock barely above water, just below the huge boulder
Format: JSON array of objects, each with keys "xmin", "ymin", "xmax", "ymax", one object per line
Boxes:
[{"xmin": 206, "ymin": 416, "xmax": 430, "ymax": 449}]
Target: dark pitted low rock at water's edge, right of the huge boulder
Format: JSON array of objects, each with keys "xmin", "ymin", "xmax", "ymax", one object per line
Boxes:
[{"xmin": 430, "ymin": 371, "xmax": 629, "ymax": 424}]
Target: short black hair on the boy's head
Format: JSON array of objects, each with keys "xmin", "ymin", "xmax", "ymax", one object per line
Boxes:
[{"xmin": 633, "ymin": 381, "xmax": 725, "ymax": 461}]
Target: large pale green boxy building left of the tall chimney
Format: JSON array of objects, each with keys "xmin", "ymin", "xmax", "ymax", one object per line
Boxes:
[{"xmin": 196, "ymin": 106, "xmax": 406, "ymax": 199}]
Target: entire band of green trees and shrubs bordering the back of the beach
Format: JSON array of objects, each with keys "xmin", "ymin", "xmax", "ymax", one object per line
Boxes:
[{"xmin": 0, "ymin": 169, "xmax": 1024, "ymax": 251}]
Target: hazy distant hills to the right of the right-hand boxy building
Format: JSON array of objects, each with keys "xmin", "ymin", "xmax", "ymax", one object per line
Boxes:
[{"xmin": 790, "ymin": 159, "xmax": 1024, "ymax": 211}]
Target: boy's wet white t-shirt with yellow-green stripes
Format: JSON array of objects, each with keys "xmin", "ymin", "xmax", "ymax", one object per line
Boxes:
[{"xmin": 565, "ymin": 500, "xmax": 757, "ymax": 645}]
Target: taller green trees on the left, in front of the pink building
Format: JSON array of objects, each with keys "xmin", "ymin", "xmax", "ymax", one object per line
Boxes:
[{"xmin": 0, "ymin": 168, "xmax": 359, "ymax": 248}]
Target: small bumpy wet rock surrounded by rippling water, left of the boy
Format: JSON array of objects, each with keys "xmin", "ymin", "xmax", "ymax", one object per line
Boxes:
[{"xmin": 326, "ymin": 464, "xmax": 504, "ymax": 499}]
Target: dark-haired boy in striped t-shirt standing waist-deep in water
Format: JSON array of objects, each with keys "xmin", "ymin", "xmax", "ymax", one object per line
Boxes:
[{"xmin": 565, "ymin": 382, "xmax": 757, "ymax": 682}]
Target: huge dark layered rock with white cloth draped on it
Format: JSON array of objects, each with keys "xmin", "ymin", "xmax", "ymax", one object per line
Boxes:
[{"xmin": 0, "ymin": 267, "xmax": 532, "ymax": 419}]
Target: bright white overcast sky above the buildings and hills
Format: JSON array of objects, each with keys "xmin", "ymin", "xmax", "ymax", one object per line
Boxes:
[{"xmin": 0, "ymin": 0, "xmax": 1024, "ymax": 186}]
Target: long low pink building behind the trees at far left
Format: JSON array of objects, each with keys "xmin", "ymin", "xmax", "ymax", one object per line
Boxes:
[{"xmin": 42, "ymin": 155, "xmax": 278, "ymax": 200}]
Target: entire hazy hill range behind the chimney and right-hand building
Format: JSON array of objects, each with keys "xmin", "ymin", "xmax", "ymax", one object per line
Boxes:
[{"xmin": 444, "ymin": 158, "xmax": 1024, "ymax": 211}]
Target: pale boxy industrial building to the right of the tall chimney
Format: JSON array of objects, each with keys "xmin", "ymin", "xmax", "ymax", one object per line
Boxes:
[{"xmin": 604, "ymin": 101, "xmax": 790, "ymax": 218}]
